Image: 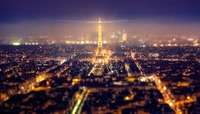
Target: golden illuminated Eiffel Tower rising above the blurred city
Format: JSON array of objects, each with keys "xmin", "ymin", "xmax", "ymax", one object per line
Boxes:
[{"xmin": 93, "ymin": 18, "xmax": 107, "ymax": 64}]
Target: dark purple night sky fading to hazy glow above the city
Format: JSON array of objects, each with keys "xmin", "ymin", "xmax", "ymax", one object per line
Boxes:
[{"xmin": 0, "ymin": 0, "xmax": 200, "ymax": 36}]
